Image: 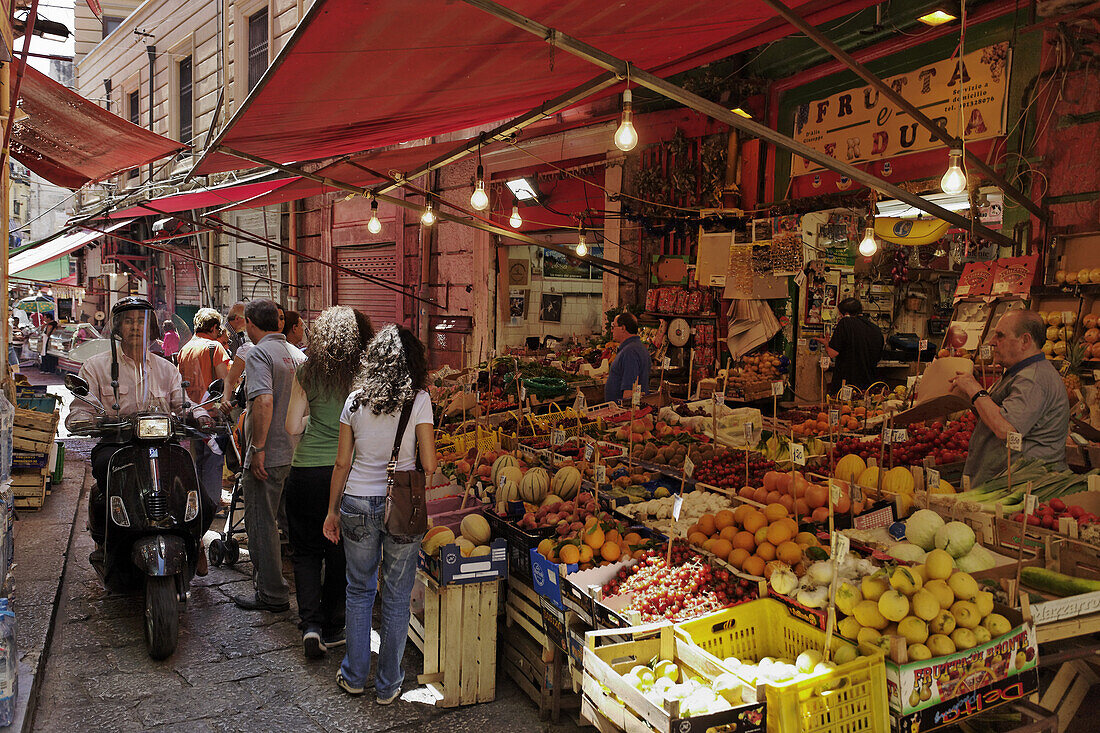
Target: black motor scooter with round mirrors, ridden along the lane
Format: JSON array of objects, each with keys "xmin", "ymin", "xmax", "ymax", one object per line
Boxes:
[{"xmin": 65, "ymin": 374, "xmax": 223, "ymax": 659}]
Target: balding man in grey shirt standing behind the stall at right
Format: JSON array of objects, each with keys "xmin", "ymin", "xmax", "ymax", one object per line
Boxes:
[{"xmin": 952, "ymin": 310, "xmax": 1069, "ymax": 484}]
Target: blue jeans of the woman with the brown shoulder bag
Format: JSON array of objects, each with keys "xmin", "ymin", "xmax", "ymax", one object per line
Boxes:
[{"xmin": 340, "ymin": 494, "xmax": 420, "ymax": 698}]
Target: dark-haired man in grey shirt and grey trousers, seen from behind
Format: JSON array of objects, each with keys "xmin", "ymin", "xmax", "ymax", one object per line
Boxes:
[{"xmin": 233, "ymin": 300, "xmax": 305, "ymax": 612}]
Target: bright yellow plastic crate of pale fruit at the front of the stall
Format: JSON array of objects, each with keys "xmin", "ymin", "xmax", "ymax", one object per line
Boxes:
[{"xmin": 677, "ymin": 599, "xmax": 890, "ymax": 733}]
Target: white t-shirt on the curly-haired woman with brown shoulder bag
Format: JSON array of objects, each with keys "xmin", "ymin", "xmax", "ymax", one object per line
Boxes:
[{"xmin": 340, "ymin": 390, "xmax": 435, "ymax": 496}]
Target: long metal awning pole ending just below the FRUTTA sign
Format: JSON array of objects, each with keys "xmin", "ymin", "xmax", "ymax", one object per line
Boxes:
[{"xmin": 455, "ymin": 0, "xmax": 1015, "ymax": 247}]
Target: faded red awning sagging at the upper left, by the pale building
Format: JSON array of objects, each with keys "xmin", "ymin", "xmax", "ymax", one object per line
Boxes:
[{"xmin": 11, "ymin": 66, "xmax": 187, "ymax": 188}]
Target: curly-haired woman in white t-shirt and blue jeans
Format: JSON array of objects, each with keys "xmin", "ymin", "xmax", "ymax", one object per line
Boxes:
[{"xmin": 325, "ymin": 326, "xmax": 436, "ymax": 705}]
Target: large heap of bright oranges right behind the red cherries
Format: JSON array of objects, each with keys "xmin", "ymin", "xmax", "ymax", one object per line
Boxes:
[{"xmin": 688, "ymin": 502, "xmax": 818, "ymax": 578}]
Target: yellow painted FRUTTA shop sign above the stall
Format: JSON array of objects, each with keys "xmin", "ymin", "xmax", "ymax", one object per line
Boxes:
[{"xmin": 792, "ymin": 42, "xmax": 1011, "ymax": 175}]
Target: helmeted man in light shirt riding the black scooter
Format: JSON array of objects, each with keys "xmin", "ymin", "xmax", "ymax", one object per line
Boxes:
[{"xmin": 65, "ymin": 296, "xmax": 203, "ymax": 565}]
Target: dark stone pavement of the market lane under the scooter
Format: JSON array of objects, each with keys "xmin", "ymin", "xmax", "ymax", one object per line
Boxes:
[{"xmin": 15, "ymin": 367, "xmax": 576, "ymax": 732}]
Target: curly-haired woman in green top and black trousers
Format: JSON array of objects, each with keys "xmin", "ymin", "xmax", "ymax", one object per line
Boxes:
[{"xmin": 285, "ymin": 306, "xmax": 374, "ymax": 659}]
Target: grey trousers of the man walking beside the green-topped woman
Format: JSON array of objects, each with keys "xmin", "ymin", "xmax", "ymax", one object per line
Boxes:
[{"xmin": 241, "ymin": 466, "xmax": 290, "ymax": 604}]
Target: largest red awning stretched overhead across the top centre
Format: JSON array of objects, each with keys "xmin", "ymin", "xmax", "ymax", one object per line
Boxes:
[{"xmin": 196, "ymin": 0, "xmax": 872, "ymax": 174}]
